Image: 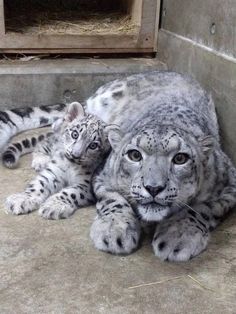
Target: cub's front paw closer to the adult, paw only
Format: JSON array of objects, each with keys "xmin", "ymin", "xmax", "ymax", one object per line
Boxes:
[{"xmin": 39, "ymin": 195, "xmax": 75, "ymax": 219}]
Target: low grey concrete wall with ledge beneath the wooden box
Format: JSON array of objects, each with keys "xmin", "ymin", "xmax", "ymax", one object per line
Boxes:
[{"xmin": 0, "ymin": 58, "xmax": 166, "ymax": 110}]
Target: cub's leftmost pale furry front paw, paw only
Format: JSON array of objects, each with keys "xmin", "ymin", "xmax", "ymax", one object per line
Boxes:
[{"xmin": 5, "ymin": 193, "xmax": 38, "ymax": 215}]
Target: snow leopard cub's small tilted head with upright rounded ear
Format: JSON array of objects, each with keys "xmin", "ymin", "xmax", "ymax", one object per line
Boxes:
[{"xmin": 52, "ymin": 102, "xmax": 110, "ymax": 167}]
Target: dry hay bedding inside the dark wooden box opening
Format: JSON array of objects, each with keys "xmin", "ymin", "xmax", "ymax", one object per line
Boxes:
[{"xmin": 5, "ymin": 10, "xmax": 137, "ymax": 35}]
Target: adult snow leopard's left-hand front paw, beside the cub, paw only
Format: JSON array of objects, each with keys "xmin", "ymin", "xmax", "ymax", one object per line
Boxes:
[{"xmin": 90, "ymin": 217, "xmax": 140, "ymax": 254}]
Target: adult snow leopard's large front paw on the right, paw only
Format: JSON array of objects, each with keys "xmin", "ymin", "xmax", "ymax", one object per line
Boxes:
[{"xmin": 152, "ymin": 218, "xmax": 209, "ymax": 262}]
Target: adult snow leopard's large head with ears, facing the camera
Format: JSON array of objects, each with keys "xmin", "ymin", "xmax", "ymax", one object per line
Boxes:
[{"xmin": 108, "ymin": 126, "xmax": 213, "ymax": 221}]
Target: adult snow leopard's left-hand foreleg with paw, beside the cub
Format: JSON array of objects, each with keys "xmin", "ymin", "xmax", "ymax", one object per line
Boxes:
[{"xmin": 90, "ymin": 178, "xmax": 140, "ymax": 254}]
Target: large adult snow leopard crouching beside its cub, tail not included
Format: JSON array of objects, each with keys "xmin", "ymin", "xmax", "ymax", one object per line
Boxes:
[{"xmin": 87, "ymin": 72, "xmax": 236, "ymax": 261}]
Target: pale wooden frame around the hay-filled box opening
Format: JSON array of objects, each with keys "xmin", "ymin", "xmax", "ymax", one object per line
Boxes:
[{"xmin": 0, "ymin": 0, "xmax": 160, "ymax": 53}]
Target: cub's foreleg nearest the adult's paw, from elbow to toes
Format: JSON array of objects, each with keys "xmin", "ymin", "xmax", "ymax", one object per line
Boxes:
[{"xmin": 39, "ymin": 183, "xmax": 95, "ymax": 219}]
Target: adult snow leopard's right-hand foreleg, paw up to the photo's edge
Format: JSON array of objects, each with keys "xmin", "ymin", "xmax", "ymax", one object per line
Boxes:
[{"xmin": 152, "ymin": 162, "xmax": 236, "ymax": 261}]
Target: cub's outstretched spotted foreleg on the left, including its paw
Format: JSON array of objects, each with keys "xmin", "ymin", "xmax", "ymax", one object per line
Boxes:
[{"xmin": 6, "ymin": 160, "xmax": 66, "ymax": 215}]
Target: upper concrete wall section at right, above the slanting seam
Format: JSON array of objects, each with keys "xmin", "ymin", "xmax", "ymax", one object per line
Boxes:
[{"xmin": 162, "ymin": 0, "xmax": 236, "ymax": 57}]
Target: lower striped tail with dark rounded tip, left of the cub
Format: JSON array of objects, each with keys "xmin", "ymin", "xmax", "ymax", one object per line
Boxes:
[{"xmin": 2, "ymin": 132, "xmax": 53, "ymax": 169}]
